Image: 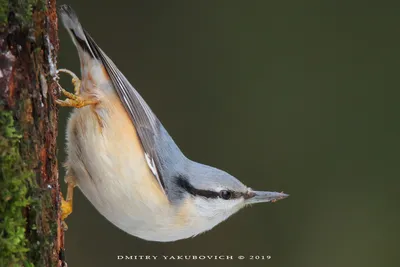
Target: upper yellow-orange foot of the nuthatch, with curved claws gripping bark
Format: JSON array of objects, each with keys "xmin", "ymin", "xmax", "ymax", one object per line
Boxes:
[{"xmin": 56, "ymin": 69, "xmax": 98, "ymax": 108}]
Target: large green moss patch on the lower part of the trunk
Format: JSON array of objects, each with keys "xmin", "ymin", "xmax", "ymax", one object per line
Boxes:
[{"xmin": 0, "ymin": 111, "xmax": 34, "ymax": 266}]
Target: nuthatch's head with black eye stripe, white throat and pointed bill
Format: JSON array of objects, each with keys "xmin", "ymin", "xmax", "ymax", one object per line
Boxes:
[{"xmin": 170, "ymin": 163, "xmax": 288, "ymax": 236}]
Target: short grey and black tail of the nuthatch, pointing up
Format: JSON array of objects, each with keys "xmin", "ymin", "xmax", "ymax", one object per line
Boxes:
[{"xmin": 59, "ymin": 5, "xmax": 95, "ymax": 57}]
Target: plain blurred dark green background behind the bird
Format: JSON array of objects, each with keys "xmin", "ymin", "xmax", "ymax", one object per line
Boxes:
[{"xmin": 58, "ymin": 0, "xmax": 400, "ymax": 267}]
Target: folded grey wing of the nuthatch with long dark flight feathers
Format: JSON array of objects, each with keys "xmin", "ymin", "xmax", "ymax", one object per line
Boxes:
[{"xmin": 84, "ymin": 31, "xmax": 165, "ymax": 193}]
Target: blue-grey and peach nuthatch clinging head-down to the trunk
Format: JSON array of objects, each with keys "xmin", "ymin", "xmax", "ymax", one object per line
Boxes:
[{"xmin": 57, "ymin": 5, "xmax": 288, "ymax": 242}]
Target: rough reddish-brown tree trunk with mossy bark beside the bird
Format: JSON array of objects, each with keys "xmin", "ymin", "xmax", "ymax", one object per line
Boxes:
[{"xmin": 0, "ymin": 0, "xmax": 64, "ymax": 266}]
